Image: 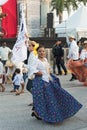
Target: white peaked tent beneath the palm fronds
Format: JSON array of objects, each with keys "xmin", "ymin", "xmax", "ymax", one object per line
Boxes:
[{"xmin": 55, "ymin": 6, "xmax": 87, "ymax": 39}]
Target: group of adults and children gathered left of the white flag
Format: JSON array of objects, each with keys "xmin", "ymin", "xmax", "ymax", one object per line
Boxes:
[{"xmin": 0, "ymin": 42, "xmax": 27, "ymax": 95}]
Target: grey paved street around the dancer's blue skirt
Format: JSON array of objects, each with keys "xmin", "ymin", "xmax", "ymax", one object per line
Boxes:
[{"xmin": 0, "ymin": 74, "xmax": 87, "ymax": 130}]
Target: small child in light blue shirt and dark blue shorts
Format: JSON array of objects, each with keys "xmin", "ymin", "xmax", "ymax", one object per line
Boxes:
[{"xmin": 11, "ymin": 68, "xmax": 23, "ymax": 95}]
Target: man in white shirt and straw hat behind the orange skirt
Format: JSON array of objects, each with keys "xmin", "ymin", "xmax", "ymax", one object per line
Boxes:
[{"xmin": 68, "ymin": 36, "xmax": 79, "ymax": 81}]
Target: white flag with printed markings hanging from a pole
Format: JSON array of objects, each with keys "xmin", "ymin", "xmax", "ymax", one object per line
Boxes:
[{"xmin": 12, "ymin": 7, "xmax": 27, "ymax": 63}]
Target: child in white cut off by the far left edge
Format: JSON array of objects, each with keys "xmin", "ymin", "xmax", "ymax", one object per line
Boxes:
[{"xmin": 0, "ymin": 57, "xmax": 5, "ymax": 92}]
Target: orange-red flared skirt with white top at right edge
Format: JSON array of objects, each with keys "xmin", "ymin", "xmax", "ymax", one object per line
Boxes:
[{"xmin": 67, "ymin": 49, "xmax": 87, "ymax": 86}]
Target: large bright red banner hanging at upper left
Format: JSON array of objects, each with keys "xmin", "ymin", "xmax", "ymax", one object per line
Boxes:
[{"xmin": 2, "ymin": 0, "xmax": 17, "ymax": 38}]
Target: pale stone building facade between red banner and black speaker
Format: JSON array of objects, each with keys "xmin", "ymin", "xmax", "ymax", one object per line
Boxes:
[{"xmin": 17, "ymin": 0, "xmax": 51, "ymax": 37}]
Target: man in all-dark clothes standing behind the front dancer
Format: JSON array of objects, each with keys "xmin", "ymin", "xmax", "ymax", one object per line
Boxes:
[{"xmin": 52, "ymin": 39, "xmax": 67, "ymax": 75}]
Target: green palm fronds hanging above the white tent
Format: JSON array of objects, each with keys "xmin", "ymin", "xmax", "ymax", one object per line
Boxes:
[{"xmin": 51, "ymin": 0, "xmax": 87, "ymax": 23}]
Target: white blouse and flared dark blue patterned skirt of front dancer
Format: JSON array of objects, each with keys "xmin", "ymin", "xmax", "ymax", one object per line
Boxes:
[{"xmin": 32, "ymin": 59, "xmax": 82, "ymax": 123}]
